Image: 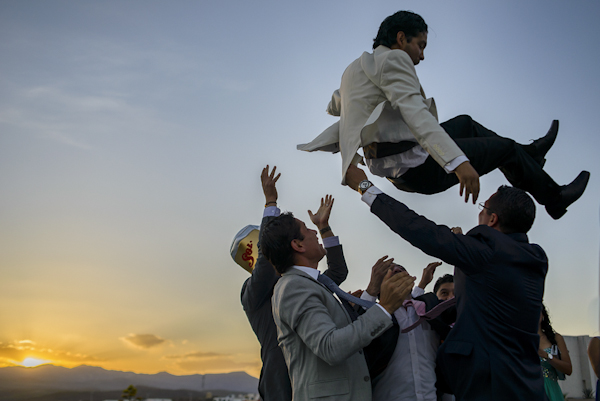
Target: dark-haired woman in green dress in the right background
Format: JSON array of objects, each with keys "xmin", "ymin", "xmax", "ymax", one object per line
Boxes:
[{"xmin": 538, "ymin": 304, "xmax": 573, "ymax": 401}]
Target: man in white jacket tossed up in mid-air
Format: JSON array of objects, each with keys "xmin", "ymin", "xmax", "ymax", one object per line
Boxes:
[{"xmin": 298, "ymin": 11, "xmax": 589, "ymax": 219}]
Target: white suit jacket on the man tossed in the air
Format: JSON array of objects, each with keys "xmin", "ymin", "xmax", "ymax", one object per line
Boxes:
[{"xmin": 297, "ymin": 46, "xmax": 464, "ymax": 184}]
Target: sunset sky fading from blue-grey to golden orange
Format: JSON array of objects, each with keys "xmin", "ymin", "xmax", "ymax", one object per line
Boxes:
[{"xmin": 0, "ymin": 0, "xmax": 600, "ymax": 376}]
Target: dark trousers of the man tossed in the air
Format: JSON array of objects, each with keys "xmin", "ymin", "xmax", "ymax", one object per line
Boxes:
[{"xmin": 388, "ymin": 115, "xmax": 560, "ymax": 205}]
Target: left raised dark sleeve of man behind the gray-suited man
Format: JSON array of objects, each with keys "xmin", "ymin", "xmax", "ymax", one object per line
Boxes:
[{"xmin": 242, "ymin": 216, "xmax": 278, "ymax": 311}]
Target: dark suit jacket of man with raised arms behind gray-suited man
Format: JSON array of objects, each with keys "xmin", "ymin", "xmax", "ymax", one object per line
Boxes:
[{"xmin": 241, "ymin": 217, "xmax": 348, "ymax": 401}]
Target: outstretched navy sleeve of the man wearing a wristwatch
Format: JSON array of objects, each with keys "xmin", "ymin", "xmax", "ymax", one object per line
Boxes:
[{"xmin": 371, "ymin": 194, "xmax": 494, "ymax": 274}]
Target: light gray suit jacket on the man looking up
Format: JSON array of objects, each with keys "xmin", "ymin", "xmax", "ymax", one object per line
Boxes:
[{"xmin": 273, "ymin": 268, "xmax": 392, "ymax": 401}]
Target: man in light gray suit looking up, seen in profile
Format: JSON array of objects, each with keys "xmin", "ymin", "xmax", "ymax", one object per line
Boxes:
[{"xmin": 260, "ymin": 209, "xmax": 415, "ymax": 401}]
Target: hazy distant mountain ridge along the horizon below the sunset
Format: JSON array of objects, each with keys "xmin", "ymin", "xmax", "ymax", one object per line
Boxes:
[{"xmin": 0, "ymin": 365, "xmax": 258, "ymax": 399}]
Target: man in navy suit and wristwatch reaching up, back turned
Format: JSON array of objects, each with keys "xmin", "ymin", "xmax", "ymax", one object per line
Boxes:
[{"xmin": 346, "ymin": 166, "xmax": 548, "ymax": 401}]
